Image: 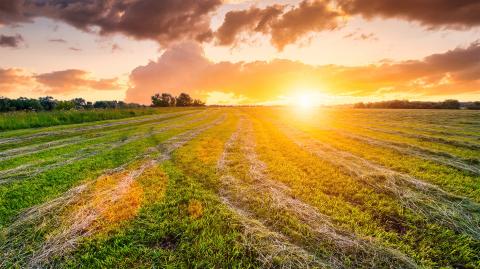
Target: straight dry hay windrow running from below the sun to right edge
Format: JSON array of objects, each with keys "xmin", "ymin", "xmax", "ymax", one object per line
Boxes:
[{"xmin": 277, "ymin": 123, "xmax": 480, "ymax": 240}]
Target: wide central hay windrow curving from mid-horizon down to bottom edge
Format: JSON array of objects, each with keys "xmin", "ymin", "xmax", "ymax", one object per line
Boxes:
[{"xmin": 218, "ymin": 118, "xmax": 415, "ymax": 268}]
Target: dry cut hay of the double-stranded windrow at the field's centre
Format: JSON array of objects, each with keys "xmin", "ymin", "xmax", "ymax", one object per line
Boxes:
[{"xmin": 218, "ymin": 116, "xmax": 415, "ymax": 268}]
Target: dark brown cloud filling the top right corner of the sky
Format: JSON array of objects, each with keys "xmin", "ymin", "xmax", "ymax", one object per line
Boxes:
[{"xmin": 336, "ymin": 0, "xmax": 480, "ymax": 28}]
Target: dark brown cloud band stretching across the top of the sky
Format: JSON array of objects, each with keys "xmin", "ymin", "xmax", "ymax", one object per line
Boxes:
[{"xmin": 0, "ymin": 0, "xmax": 480, "ymax": 50}]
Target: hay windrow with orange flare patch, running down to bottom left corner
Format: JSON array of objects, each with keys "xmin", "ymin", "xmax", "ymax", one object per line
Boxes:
[{"xmin": 0, "ymin": 114, "xmax": 226, "ymax": 268}]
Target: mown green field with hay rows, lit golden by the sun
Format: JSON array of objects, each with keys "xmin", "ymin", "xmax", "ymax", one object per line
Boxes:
[{"xmin": 0, "ymin": 108, "xmax": 480, "ymax": 268}]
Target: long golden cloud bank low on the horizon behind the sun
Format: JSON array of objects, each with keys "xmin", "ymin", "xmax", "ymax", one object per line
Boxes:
[{"xmin": 126, "ymin": 42, "xmax": 480, "ymax": 103}]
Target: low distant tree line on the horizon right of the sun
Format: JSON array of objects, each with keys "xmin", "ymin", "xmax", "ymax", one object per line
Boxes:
[{"xmin": 353, "ymin": 99, "xmax": 480, "ymax": 109}]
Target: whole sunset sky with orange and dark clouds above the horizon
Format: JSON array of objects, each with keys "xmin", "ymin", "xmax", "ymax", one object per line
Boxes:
[{"xmin": 0, "ymin": 0, "xmax": 480, "ymax": 105}]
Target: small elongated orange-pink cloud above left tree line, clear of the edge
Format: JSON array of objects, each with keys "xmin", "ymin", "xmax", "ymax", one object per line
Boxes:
[{"xmin": 35, "ymin": 69, "xmax": 121, "ymax": 94}]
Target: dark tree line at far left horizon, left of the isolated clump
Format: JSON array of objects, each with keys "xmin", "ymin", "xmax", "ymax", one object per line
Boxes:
[{"xmin": 0, "ymin": 96, "xmax": 145, "ymax": 112}]
